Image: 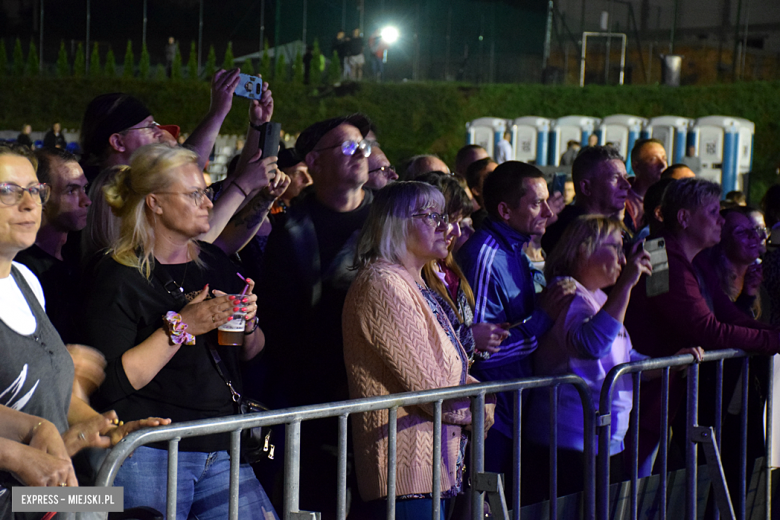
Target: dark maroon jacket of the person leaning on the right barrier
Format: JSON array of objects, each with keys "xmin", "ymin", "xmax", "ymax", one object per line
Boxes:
[{"xmin": 624, "ymin": 233, "xmax": 780, "ymax": 472}]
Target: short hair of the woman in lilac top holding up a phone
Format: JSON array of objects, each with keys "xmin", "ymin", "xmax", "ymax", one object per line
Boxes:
[{"xmin": 544, "ymin": 215, "xmax": 626, "ymax": 281}]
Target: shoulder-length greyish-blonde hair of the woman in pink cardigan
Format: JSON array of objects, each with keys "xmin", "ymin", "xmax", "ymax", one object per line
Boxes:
[{"xmin": 355, "ymin": 181, "xmax": 444, "ymax": 267}]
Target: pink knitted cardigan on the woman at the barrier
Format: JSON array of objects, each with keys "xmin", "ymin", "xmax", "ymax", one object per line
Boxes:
[{"xmin": 342, "ymin": 260, "xmax": 493, "ymax": 501}]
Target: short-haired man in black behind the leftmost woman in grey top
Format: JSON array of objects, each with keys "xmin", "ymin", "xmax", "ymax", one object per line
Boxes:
[{"xmin": 16, "ymin": 148, "xmax": 92, "ymax": 343}]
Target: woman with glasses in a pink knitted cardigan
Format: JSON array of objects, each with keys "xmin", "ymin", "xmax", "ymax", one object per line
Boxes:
[{"xmin": 343, "ymin": 182, "xmax": 492, "ymax": 519}]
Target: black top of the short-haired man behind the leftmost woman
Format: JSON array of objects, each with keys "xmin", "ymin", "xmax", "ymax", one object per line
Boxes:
[{"xmin": 15, "ymin": 241, "xmax": 83, "ymax": 343}]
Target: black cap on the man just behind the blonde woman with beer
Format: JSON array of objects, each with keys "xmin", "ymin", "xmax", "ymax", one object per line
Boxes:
[{"xmin": 81, "ymin": 92, "xmax": 152, "ymax": 156}]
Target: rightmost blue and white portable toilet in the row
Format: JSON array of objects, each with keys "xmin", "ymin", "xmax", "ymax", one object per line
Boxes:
[{"xmin": 689, "ymin": 116, "xmax": 756, "ymax": 196}]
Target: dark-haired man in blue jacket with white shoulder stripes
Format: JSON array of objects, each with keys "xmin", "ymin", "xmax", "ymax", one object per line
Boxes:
[{"xmin": 458, "ymin": 161, "xmax": 574, "ymax": 496}]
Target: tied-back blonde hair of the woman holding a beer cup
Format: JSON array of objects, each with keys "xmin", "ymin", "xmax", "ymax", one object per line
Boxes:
[{"xmin": 103, "ymin": 143, "xmax": 198, "ymax": 278}]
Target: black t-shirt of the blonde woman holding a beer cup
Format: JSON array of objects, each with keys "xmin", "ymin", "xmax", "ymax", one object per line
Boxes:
[{"xmin": 84, "ymin": 243, "xmax": 244, "ymax": 451}]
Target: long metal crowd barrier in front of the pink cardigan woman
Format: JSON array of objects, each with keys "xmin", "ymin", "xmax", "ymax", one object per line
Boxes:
[{"xmin": 95, "ymin": 374, "xmax": 596, "ymax": 520}]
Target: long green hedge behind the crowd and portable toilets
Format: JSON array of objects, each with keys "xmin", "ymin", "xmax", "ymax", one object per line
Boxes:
[{"xmin": 0, "ymin": 77, "xmax": 780, "ymax": 200}]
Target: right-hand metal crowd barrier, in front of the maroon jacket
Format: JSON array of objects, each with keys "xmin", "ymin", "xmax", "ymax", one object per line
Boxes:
[{"xmin": 596, "ymin": 350, "xmax": 773, "ymax": 520}]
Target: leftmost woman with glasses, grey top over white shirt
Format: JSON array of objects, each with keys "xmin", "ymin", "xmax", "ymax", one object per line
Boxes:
[{"xmin": 0, "ymin": 147, "xmax": 167, "ymax": 518}]
